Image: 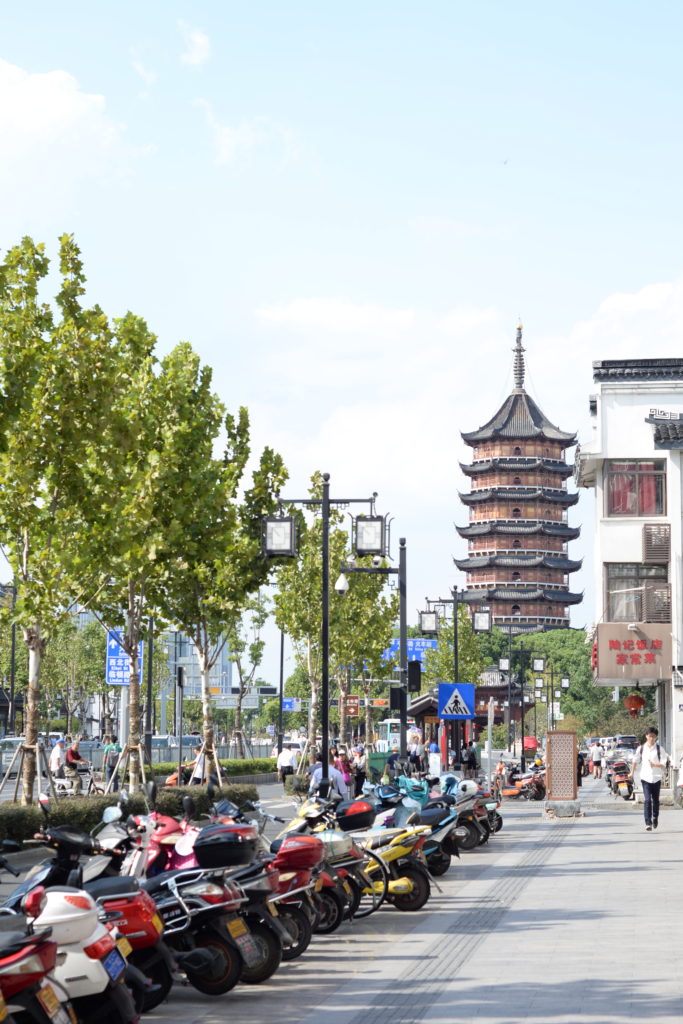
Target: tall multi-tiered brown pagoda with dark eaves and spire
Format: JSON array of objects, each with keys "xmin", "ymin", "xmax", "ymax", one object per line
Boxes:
[{"xmin": 456, "ymin": 325, "xmax": 583, "ymax": 634}]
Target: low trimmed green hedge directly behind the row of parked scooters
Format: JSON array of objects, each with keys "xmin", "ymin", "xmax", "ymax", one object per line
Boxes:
[{"xmin": 0, "ymin": 785, "xmax": 258, "ymax": 843}]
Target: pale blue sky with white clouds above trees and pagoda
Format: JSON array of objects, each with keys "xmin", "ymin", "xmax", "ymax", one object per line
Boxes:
[{"xmin": 0, "ymin": 0, "xmax": 683, "ymax": 684}]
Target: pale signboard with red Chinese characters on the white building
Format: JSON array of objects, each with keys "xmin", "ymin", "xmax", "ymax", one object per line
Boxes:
[{"xmin": 593, "ymin": 623, "xmax": 672, "ymax": 686}]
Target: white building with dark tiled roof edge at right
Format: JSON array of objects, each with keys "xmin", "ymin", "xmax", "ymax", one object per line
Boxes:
[{"xmin": 577, "ymin": 358, "xmax": 683, "ymax": 765}]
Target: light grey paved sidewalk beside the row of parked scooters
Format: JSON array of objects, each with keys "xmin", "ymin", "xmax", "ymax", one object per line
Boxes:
[{"xmin": 141, "ymin": 779, "xmax": 683, "ymax": 1024}]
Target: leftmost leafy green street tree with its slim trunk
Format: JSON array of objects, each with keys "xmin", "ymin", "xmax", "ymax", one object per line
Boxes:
[{"xmin": 0, "ymin": 236, "xmax": 151, "ymax": 803}]
